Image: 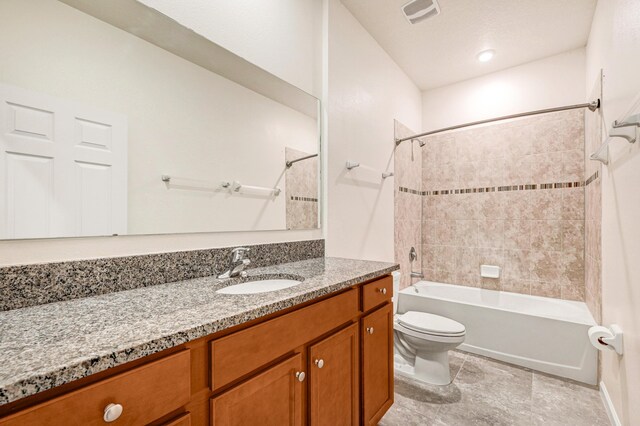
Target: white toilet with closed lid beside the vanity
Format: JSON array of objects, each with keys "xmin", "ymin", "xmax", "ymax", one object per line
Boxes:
[{"xmin": 393, "ymin": 272, "xmax": 465, "ymax": 385}]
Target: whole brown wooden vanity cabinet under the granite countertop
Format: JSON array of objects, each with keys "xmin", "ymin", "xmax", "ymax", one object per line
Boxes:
[{"xmin": 0, "ymin": 276, "xmax": 393, "ymax": 426}]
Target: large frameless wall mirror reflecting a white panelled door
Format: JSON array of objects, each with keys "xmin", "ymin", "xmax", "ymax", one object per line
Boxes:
[{"xmin": 0, "ymin": 0, "xmax": 321, "ymax": 239}]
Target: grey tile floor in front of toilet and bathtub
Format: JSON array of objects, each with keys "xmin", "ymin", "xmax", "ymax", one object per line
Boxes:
[{"xmin": 379, "ymin": 352, "xmax": 609, "ymax": 426}]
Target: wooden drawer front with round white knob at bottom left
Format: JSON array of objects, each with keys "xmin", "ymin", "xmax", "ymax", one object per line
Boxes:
[{"xmin": 0, "ymin": 350, "xmax": 191, "ymax": 426}]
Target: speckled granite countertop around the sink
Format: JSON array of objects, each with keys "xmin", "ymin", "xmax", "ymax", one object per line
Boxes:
[{"xmin": 0, "ymin": 258, "xmax": 398, "ymax": 405}]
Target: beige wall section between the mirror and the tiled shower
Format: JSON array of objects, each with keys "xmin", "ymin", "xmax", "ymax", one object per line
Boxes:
[{"xmin": 327, "ymin": 0, "xmax": 421, "ymax": 261}]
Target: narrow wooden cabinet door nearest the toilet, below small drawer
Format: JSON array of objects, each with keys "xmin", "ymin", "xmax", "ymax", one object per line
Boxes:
[{"xmin": 360, "ymin": 304, "xmax": 393, "ymax": 425}]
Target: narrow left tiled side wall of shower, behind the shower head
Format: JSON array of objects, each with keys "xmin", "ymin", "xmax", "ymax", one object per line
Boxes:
[{"xmin": 393, "ymin": 121, "xmax": 422, "ymax": 288}]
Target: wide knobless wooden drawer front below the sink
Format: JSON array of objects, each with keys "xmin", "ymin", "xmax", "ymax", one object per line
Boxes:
[{"xmin": 210, "ymin": 289, "xmax": 358, "ymax": 390}]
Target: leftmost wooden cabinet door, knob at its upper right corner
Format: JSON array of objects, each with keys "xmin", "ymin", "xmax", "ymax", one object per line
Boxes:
[{"xmin": 211, "ymin": 354, "xmax": 305, "ymax": 426}]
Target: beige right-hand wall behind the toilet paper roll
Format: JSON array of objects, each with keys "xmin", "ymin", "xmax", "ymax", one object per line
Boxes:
[{"xmin": 586, "ymin": 0, "xmax": 640, "ymax": 425}]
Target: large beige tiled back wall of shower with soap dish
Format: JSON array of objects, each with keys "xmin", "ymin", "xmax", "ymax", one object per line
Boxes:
[{"xmin": 422, "ymin": 110, "xmax": 585, "ymax": 300}]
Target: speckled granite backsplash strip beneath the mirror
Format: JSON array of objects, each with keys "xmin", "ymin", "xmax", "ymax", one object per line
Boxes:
[{"xmin": 0, "ymin": 240, "xmax": 324, "ymax": 311}]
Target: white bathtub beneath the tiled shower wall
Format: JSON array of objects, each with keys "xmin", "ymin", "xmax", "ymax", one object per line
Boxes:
[{"xmin": 398, "ymin": 281, "xmax": 598, "ymax": 385}]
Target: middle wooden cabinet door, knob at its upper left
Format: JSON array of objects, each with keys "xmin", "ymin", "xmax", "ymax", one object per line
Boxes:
[{"xmin": 309, "ymin": 324, "xmax": 359, "ymax": 426}]
